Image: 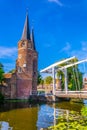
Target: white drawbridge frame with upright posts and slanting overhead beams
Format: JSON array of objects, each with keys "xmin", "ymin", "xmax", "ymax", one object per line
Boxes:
[{"xmin": 40, "ymin": 56, "xmax": 87, "ymax": 95}]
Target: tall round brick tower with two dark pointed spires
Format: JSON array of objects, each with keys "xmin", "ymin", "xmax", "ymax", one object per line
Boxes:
[{"xmin": 16, "ymin": 14, "xmax": 38, "ymax": 99}]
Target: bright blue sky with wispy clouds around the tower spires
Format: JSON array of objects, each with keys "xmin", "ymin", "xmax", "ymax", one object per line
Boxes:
[{"xmin": 0, "ymin": 0, "xmax": 87, "ymax": 72}]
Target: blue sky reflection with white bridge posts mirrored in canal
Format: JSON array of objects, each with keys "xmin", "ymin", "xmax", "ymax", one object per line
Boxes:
[{"xmin": 37, "ymin": 104, "xmax": 69, "ymax": 130}]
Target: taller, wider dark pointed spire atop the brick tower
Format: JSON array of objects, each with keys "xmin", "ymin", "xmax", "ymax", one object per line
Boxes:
[{"xmin": 21, "ymin": 13, "xmax": 30, "ymax": 40}]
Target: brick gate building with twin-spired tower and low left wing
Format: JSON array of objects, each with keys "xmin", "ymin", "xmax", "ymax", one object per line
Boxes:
[{"xmin": 1, "ymin": 15, "xmax": 38, "ymax": 99}]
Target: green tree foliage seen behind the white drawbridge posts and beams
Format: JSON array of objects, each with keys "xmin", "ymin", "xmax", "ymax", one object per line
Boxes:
[{"xmin": 57, "ymin": 58, "xmax": 83, "ymax": 90}]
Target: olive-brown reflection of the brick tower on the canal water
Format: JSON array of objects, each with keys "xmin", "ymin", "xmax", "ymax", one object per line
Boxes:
[{"xmin": 0, "ymin": 103, "xmax": 38, "ymax": 130}]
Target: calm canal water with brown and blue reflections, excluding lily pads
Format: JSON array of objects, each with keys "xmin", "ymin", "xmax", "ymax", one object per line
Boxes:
[{"xmin": 0, "ymin": 102, "xmax": 87, "ymax": 130}]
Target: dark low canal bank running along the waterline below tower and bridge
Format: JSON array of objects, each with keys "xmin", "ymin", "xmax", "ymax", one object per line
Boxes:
[{"xmin": 1, "ymin": 95, "xmax": 83, "ymax": 104}]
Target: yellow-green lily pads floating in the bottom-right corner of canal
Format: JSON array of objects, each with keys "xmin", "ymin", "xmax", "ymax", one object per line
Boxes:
[{"xmin": 48, "ymin": 107, "xmax": 87, "ymax": 130}]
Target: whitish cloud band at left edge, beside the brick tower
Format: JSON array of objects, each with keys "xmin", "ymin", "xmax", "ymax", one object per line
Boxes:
[{"xmin": 0, "ymin": 46, "xmax": 17, "ymax": 58}]
